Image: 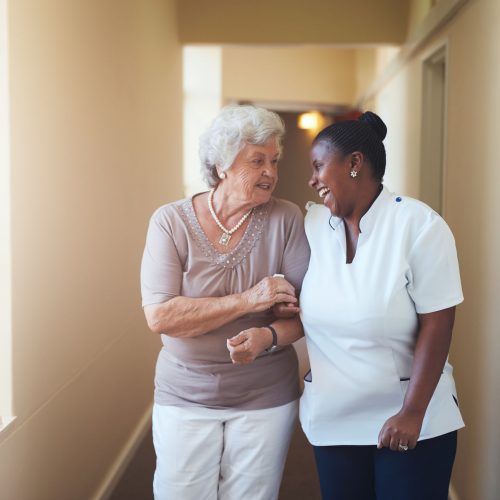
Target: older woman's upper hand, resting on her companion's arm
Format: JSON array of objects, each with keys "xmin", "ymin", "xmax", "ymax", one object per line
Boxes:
[{"xmin": 242, "ymin": 276, "xmax": 297, "ymax": 312}]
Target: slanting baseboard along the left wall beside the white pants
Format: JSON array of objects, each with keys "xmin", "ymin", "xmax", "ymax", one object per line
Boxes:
[{"xmin": 92, "ymin": 406, "xmax": 153, "ymax": 500}]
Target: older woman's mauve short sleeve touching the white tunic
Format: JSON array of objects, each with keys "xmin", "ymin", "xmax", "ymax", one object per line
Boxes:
[{"xmin": 281, "ymin": 205, "xmax": 310, "ymax": 294}]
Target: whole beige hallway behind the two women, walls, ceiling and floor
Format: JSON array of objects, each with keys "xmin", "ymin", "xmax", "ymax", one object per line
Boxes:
[{"xmin": 0, "ymin": 0, "xmax": 500, "ymax": 500}]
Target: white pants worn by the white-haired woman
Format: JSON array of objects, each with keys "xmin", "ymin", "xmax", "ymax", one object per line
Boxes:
[{"xmin": 153, "ymin": 401, "xmax": 298, "ymax": 500}]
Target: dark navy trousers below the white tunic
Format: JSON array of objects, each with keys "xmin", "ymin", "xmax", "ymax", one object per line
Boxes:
[{"xmin": 314, "ymin": 431, "xmax": 457, "ymax": 500}]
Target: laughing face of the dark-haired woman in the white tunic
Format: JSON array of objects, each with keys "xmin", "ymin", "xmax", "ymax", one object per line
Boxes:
[{"xmin": 309, "ymin": 141, "xmax": 356, "ymax": 218}]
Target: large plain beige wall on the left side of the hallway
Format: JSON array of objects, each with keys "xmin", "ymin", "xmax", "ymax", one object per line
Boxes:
[{"xmin": 0, "ymin": 0, "xmax": 182, "ymax": 500}]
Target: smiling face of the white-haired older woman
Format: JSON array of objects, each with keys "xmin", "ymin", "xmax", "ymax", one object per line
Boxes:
[{"xmin": 224, "ymin": 139, "xmax": 279, "ymax": 206}]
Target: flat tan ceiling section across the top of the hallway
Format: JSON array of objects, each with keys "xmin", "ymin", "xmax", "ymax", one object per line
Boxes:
[{"xmin": 177, "ymin": 0, "xmax": 412, "ymax": 44}]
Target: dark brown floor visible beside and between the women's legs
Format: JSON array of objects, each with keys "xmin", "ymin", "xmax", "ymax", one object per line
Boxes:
[{"xmin": 110, "ymin": 424, "xmax": 321, "ymax": 500}]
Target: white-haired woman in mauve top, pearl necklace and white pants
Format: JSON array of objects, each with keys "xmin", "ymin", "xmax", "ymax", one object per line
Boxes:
[{"xmin": 141, "ymin": 106, "xmax": 309, "ymax": 500}]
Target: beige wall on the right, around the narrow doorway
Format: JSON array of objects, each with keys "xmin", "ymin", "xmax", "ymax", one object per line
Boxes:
[{"xmin": 364, "ymin": 0, "xmax": 500, "ymax": 500}]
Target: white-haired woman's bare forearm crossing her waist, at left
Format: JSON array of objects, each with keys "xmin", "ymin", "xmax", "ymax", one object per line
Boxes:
[{"xmin": 144, "ymin": 294, "xmax": 250, "ymax": 337}]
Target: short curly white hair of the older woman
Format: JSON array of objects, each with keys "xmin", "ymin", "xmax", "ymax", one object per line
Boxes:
[{"xmin": 199, "ymin": 105, "xmax": 285, "ymax": 187}]
